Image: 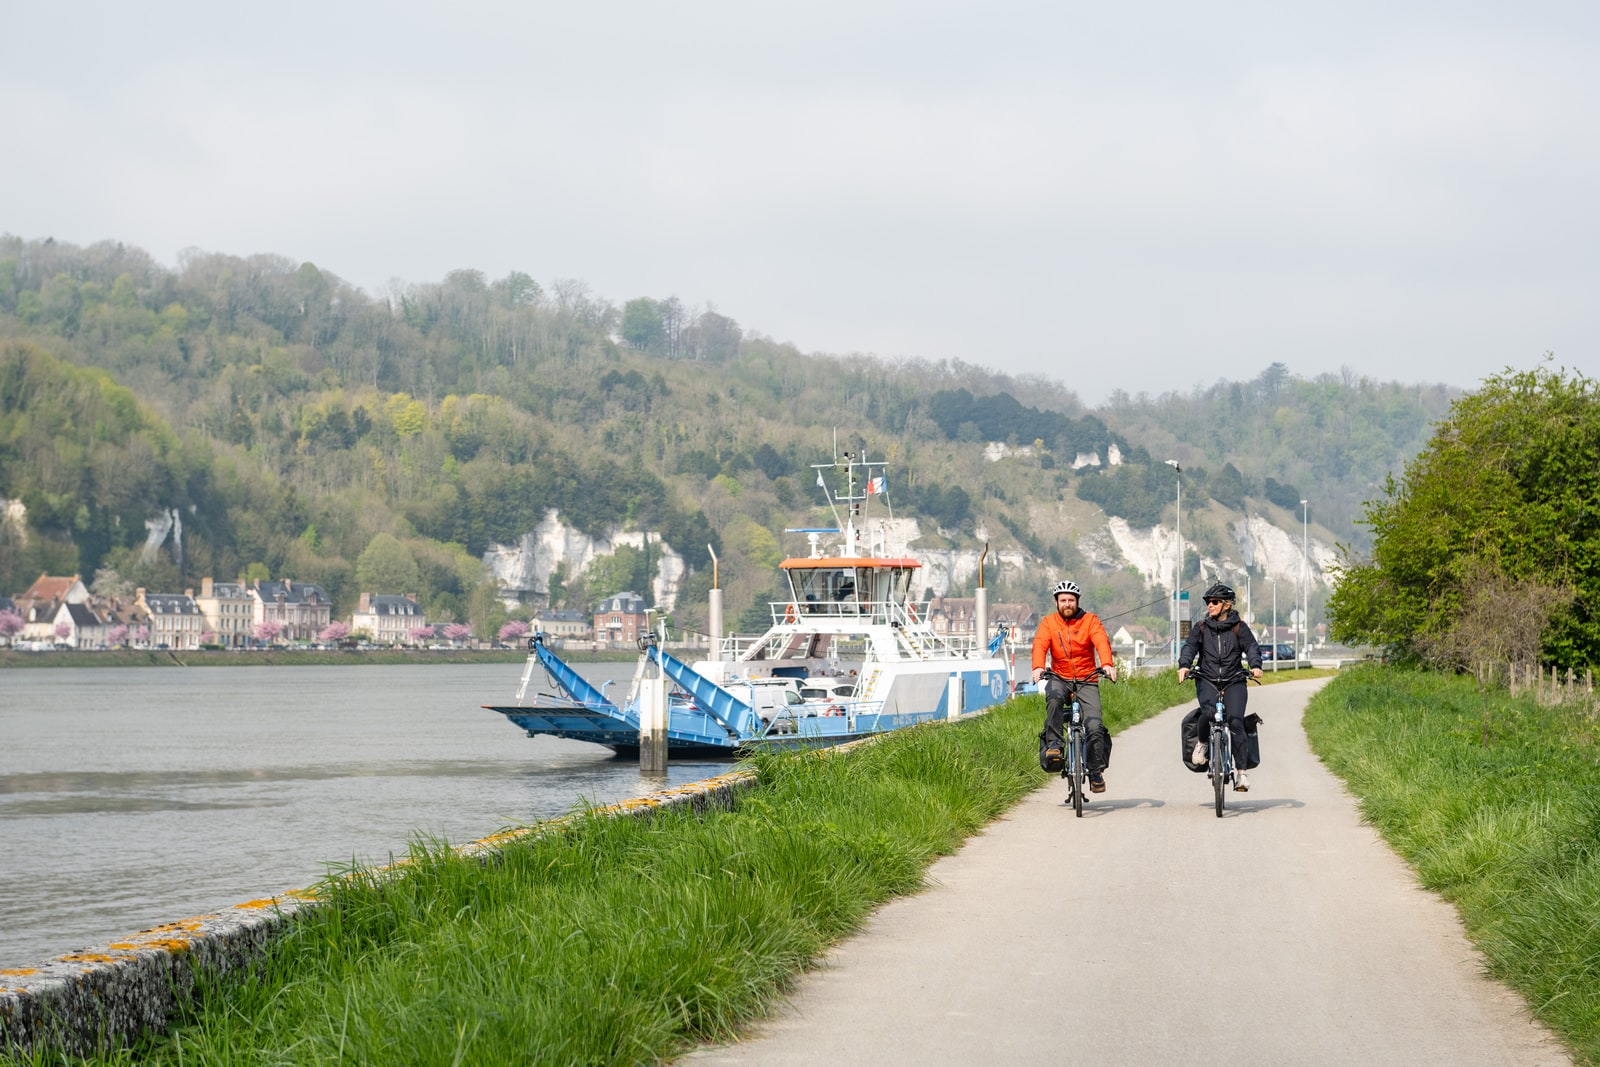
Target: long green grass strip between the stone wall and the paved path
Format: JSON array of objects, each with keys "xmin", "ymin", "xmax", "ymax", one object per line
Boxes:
[{"xmin": 38, "ymin": 678, "xmax": 1187, "ymax": 1065}]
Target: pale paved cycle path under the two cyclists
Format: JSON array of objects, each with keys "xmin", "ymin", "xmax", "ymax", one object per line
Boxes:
[{"xmin": 677, "ymin": 680, "xmax": 1571, "ymax": 1067}]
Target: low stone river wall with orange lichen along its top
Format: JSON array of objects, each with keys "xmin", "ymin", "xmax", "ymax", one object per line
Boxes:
[{"xmin": 0, "ymin": 771, "xmax": 755, "ymax": 1054}]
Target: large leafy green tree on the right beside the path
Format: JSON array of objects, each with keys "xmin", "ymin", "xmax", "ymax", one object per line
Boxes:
[{"xmin": 1328, "ymin": 366, "xmax": 1600, "ymax": 667}]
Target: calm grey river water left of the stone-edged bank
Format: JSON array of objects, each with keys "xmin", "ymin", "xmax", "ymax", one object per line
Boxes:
[{"xmin": 0, "ymin": 664, "xmax": 731, "ymax": 968}]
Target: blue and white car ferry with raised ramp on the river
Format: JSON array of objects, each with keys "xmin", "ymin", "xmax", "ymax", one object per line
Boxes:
[{"xmin": 485, "ymin": 453, "xmax": 1013, "ymax": 758}]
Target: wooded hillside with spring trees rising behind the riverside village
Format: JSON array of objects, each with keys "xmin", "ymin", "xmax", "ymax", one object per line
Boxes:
[{"xmin": 0, "ymin": 237, "xmax": 1450, "ymax": 633}]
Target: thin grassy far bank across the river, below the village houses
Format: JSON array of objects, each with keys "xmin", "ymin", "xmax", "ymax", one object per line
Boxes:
[{"xmin": 0, "ymin": 648, "xmax": 638, "ymax": 670}]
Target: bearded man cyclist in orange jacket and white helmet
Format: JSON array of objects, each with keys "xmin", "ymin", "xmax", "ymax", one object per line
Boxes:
[{"xmin": 1034, "ymin": 582, "xmax": 1117, "ymax": 793}]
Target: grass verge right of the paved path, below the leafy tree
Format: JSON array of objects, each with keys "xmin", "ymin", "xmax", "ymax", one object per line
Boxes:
[{"xmin": 1306, "ymin": 667, "xmax": 1600, "ymax": 1064}]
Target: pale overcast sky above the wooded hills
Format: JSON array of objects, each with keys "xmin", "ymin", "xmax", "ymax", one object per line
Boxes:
[{"xmin": 0, "ymin": 0, "xmax": 1600, "ymax": 403}]
